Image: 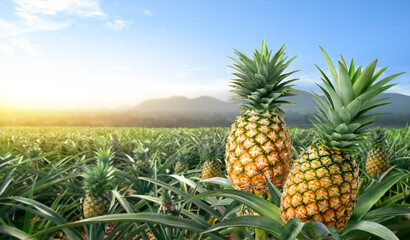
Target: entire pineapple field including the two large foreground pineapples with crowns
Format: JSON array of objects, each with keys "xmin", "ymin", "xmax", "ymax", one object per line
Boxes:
[{"xmin": 0, "ymin": 41, "xmax": 410, "ymax": 240}]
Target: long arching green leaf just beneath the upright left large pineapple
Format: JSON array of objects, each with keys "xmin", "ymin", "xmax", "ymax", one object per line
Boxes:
[{"xmin": 186, "ymin": 189, "xmax": 282, "ymax": 223}]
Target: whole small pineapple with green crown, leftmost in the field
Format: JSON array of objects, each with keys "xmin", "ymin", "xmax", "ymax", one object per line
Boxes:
[{"xmin": 82, "ymin": 150, "xmax": 114, "ymax": 218}]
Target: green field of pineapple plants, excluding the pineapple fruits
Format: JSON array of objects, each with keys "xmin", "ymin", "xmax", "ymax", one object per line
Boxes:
[{"xmin": 0, "ymin": 126, "xmax": 410, "ymax": 240}]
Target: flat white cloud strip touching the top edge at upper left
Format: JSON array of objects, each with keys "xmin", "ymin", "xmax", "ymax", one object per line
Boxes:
[{"xmin": 14, "ymin": 0, "xmax": 105, "ymax": 17}]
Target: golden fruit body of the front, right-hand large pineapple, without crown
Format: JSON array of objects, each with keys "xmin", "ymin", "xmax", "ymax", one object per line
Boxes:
[{"xmin": 280, "ymin": 145, "xmax": 359, "ymax": 232}]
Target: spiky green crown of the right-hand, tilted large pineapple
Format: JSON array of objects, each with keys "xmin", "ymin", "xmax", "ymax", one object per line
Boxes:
[{"xmin": 312, "ymin": 47, "xmax": 403, "ymax": 152}]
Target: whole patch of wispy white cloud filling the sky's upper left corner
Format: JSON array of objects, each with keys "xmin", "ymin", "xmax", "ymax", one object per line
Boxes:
[{"xmin": 0, "ymin": 0, "xmax": 106, "ymax": 59}]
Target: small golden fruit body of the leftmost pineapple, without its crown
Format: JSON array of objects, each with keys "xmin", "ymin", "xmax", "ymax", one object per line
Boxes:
[{"xmin": 83, "ymin": 192, "xmax": 110, "ymax": 218}]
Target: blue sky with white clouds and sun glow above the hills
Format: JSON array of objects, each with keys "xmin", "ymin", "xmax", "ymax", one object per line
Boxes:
[{"xmin": 0, "ymin": 0, "xmax": 410, "ymax": 108}]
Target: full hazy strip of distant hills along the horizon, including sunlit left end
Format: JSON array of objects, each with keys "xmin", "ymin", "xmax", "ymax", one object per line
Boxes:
[{"xmin": 0, "ymin": 91, "xmax": 410, "ymax": 127}]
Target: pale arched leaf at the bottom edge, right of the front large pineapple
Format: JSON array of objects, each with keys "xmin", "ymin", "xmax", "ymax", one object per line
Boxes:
[{"xmin": 341, "ymin": 221, "xmax": 399, "ymax": 240}]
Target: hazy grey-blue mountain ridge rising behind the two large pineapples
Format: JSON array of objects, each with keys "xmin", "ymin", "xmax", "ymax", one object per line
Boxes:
[{"xmin": 128, "ymin": 90, "xmax": 410, "ymax": 127}]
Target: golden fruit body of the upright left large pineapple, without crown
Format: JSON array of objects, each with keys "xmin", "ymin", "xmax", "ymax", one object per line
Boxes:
[{"xmin": 225, "ymin": 110, "xmax": 293, "ymax": 194}]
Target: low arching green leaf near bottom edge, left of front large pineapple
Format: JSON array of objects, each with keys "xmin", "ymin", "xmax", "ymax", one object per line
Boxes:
[{"xmin": 205, "ymin": 216, "xmax": 284, "ymax": 237}]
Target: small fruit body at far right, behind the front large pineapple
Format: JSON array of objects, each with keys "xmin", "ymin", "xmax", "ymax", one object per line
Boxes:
[{"xmin": 366, "ymin": 147, "xmax": 390, "ymax": 178}]
